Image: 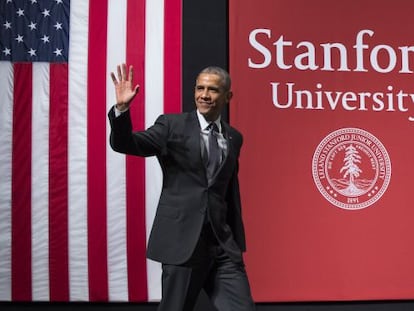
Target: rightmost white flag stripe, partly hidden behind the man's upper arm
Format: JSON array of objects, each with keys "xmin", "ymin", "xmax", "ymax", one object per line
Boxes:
[{"xmin": 145, "ymin": 0, "xmax": 164, "ymax": 301}]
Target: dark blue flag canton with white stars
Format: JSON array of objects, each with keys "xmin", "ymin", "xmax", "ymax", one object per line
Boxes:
[{"xmin": 0, "ymin": 0, "xmax": 70, "ymax": 63}]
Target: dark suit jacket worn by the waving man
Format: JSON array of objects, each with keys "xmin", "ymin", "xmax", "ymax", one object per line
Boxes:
[{"xmin": 109, "ymin": 108, "xmax": 246, "ymax": 264}]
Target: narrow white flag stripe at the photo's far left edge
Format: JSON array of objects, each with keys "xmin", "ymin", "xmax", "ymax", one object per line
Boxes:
[{"xmin": 0, "ymin": 62, "xmax": 13, "ymax": 301}]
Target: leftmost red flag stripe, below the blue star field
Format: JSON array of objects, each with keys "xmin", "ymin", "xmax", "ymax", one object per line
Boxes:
[{"xmin": 11, "ymin": 64, "xmax": 32, "ymax": 301}]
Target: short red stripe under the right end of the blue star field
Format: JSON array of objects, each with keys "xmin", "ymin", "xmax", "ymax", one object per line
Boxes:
[{"xmin": 49, "ymin": 64, "xmax": 69, "ymax": 301}]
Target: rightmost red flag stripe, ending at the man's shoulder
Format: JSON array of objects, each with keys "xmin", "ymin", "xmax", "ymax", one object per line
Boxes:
[{"xmin": 164, "ymin": 0, "xmax": 182, "ymax": 113}]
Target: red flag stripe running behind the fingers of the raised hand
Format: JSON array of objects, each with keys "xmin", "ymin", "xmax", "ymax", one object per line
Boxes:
[{"xmin": 126, "ymin": 0, "xmax": 148, "ymax": 301}]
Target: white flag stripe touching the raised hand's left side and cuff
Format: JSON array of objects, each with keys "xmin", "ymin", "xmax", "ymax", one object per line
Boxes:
[{"xmin": 102, "ymin": 0, "xmax": 128, "ymax": 301}]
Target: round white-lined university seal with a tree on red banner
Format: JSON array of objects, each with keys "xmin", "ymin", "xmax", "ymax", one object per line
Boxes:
[{"xmin": 312, "ymin": 128, "xmax": 391, "ymax": 210}]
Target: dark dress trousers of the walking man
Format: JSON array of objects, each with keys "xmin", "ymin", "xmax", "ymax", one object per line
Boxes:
[{"xmin": 158, "ymin": 224, "xmax": 255, "ymax": 311}]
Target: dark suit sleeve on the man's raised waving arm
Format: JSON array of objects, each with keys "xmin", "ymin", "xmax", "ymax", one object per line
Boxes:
[{"xmin": 108, "ymin": 108, "xmax": 168, "ymax": 157}]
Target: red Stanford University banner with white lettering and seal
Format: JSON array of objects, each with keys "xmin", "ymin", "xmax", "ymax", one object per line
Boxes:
[{"xmin": 230, "ymin": 0, "xmax": 414, "ymax": 302}]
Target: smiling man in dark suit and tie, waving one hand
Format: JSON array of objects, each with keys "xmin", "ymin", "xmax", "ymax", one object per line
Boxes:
[{"xmin": 109, "ymin": 64, "xmax": 255, "ymax": 311}]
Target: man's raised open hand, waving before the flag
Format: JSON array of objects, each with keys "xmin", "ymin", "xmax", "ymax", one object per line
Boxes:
[{"xmin": 111, "ymin": 64, "xmax": 139, "ymax": 111}]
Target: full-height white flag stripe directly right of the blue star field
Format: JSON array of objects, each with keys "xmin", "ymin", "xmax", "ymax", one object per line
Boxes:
[{"xmin": 68, "ymin": 0, "xmax": 89, "ymax": 301}]
